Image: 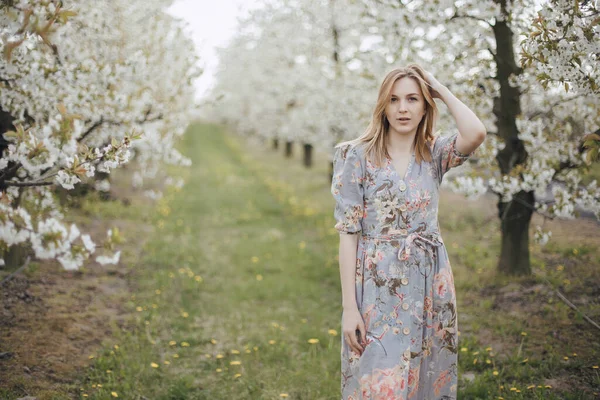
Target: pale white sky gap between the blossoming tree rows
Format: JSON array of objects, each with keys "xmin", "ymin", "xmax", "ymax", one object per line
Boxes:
[{"xmin": 169, "ymin": 0, "xmax": 259, "ymax": 100}]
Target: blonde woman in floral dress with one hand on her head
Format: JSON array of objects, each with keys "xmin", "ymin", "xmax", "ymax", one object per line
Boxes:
[{"xmin": 331, "ymin": 64, "xmax": 486, "ymax": 400}]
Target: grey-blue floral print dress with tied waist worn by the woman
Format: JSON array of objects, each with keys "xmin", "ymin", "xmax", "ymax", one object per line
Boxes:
[{"xmin": 331, "ymin": 133, "xmax": 473, "ymax": 400}]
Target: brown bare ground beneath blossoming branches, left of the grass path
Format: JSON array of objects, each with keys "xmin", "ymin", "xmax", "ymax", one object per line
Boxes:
[{"xmin": 0, "ymin": 177, "xmax": 153, "ymax": 400}]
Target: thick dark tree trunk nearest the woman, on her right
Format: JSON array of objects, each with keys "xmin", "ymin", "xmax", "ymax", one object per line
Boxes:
[{"xmin": 492, "ymin": 0, "xmax": 535, "ymax": 275}]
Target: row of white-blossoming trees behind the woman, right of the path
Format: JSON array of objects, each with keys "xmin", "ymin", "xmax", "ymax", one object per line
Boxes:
[{"xmin": 205, "ymin": 0, "xmax": 600, "ymax": 274}]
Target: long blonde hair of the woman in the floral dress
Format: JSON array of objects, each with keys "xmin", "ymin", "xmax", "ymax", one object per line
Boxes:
[{"xmin": 335, "ymin": 63, "xmax": 438, "ymax": 167}]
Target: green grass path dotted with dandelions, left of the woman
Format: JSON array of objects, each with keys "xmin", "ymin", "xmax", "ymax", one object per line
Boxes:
[{"xmin": 75, "ymin": 126, "xmax": 341, "ymax": 399}]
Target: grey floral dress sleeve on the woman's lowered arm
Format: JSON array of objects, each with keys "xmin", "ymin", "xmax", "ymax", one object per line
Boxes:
[{"xmin": 331, "ymin": 145, "xmax": 364, "ymax": 234}]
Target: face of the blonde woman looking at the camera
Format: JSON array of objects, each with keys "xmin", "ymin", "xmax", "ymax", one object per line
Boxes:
[{"xmin": 385, "ymin": 76, "xmax": 425, "ymax": 139}]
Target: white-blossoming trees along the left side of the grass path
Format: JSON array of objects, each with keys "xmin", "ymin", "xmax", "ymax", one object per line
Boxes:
[{"xmin": 0, "ymin": 0, "xmax": 202, "ymax": 269}]
